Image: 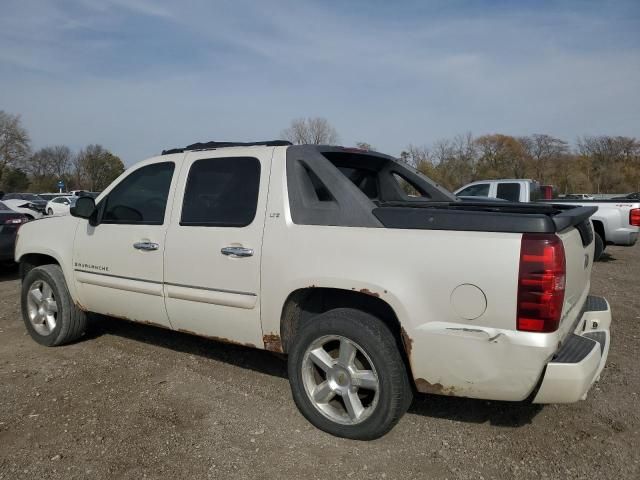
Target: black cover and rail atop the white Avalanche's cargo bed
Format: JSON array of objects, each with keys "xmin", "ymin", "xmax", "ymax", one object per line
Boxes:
[{"xmin": 373, "ymin": 202, "xmax": 598, "ymax": 233}]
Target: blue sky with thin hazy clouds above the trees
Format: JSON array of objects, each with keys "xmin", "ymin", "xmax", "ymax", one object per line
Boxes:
[{"xmin": 0, "ymin": 0, "xmax": 640, "ymax": 165}]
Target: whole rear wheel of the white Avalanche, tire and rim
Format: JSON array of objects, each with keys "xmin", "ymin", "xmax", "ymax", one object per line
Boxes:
[{"xmin": 289, "ymin": 308, "xmax": 412, "ymax": 440}]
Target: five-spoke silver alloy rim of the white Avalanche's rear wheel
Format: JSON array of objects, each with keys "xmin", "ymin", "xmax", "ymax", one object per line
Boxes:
[{"xmin": 302, "ymin": 335, "xmax": 380, "ymax": 425}]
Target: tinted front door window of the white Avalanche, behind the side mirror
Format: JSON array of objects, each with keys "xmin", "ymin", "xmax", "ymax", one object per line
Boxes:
[{"xmin": 101, "ymin": 162, "xmax": 174, "ymax": 225}]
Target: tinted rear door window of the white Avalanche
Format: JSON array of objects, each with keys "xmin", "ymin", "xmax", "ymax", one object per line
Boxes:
[{"xmin": 180, "ymin": 157, "xmax": 260, "ymax": 227}]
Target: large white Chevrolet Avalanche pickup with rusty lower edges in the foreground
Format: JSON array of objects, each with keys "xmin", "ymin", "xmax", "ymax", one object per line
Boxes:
[{"xmin": 15, "ymin": 141, "xmax": 611, "ymax": 439}]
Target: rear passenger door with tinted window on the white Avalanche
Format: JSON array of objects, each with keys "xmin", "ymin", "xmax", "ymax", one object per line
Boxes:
[{"xmin": 164, "ymin": 148, "xmax": 273, "ymax": 346}]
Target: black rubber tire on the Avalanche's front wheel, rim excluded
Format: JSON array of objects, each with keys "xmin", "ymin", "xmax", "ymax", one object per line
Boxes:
[{"xmin": 21, "ymin": 265, "xmax": 87, "ymax": 347}]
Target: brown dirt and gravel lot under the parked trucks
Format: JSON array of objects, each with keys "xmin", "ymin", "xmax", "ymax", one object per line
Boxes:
[{"xmin": 0, "ymin": 247, "xmax": 640, "ymax": 479}]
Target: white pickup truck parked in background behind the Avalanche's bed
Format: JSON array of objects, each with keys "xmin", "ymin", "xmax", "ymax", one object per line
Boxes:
[{"xmin": 454, "ymin": 178, "xmax": 640, "ymax": 260}]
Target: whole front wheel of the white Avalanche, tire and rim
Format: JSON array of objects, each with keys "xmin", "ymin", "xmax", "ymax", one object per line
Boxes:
[{"xmin": 21, "ymin": 265, "xmax": 87, "ymax": 347}]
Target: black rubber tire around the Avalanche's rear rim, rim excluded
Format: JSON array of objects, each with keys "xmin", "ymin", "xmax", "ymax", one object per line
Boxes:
[{"xmin": 288, "ymin": 308, "xmax": 413, "ymax": 440}]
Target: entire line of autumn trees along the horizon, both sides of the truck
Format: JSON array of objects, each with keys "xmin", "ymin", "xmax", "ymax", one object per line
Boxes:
[{"xmin": 0, "ymin": 110, "xmax": 640, "ymax": 193}]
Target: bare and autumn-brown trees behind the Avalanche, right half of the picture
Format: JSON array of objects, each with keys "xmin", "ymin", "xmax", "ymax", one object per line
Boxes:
[{"xmin": 282, "ymin": 118, "xmax": 640, "ymax": 193}]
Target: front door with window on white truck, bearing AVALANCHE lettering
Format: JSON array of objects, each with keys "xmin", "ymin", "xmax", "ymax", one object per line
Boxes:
[{"xmin": 73, "ymin": 162, "xmax": 175, "ymax": 327}]
